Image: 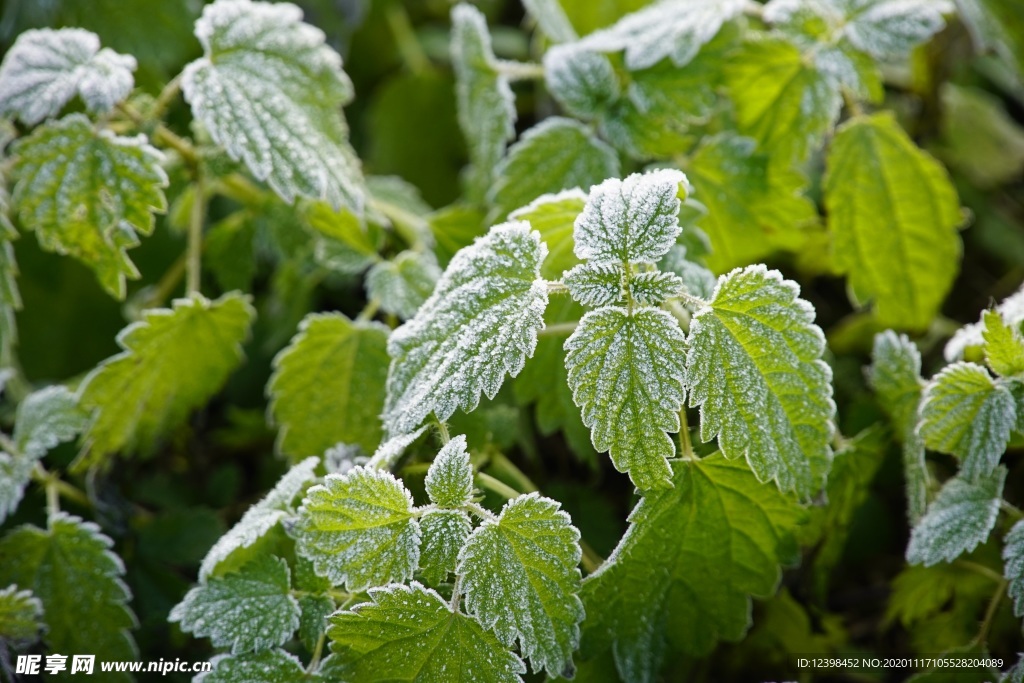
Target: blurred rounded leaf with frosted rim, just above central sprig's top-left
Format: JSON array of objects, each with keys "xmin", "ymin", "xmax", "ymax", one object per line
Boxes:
[{"xmin": 492, "ymin": 117, "xmax": 620, "ymax": 219}]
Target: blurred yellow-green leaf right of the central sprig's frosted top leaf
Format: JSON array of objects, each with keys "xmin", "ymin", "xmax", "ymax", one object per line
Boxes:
[{"xmin": 686, "ymin": 134, "xmax": 818, "ymax": 271}]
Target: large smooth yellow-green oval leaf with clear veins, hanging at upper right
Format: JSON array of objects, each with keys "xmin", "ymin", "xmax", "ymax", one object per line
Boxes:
[{"xmin": 824, "ymin": 113, "xmax": 962, "ymax": 330}]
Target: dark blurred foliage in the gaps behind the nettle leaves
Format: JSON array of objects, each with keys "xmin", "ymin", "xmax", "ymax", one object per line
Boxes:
[{"xmin": 0, "ymin": 0, "xmax": 1024, "ymax": 681}]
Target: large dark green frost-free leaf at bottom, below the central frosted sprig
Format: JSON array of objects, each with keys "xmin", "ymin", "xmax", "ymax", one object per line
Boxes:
[{"xmin": 583, "ymin": 455, "xmax": 803, "ymax": 683}]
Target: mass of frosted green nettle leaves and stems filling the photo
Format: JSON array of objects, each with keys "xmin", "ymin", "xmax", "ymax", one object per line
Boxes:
[{"xmin": 0, "ymin": 0, "xmax": 1024, "ymax": 683}]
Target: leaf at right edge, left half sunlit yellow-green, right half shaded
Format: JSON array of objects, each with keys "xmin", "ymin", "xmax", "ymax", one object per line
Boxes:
[{"xmin": 919, "ymin": 362, "xmax": 1017, "ymax": 481}]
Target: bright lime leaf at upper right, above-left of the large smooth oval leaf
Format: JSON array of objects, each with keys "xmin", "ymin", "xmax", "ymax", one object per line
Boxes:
[{"xmin": 726, "ymin": 38, "xmax": 842, "ymax": 161}]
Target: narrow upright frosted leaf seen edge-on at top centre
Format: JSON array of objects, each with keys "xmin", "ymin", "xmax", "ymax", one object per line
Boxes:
[{"xmin": 452, "ymin": 3, "xmax": 515, "ymax": 201}]
